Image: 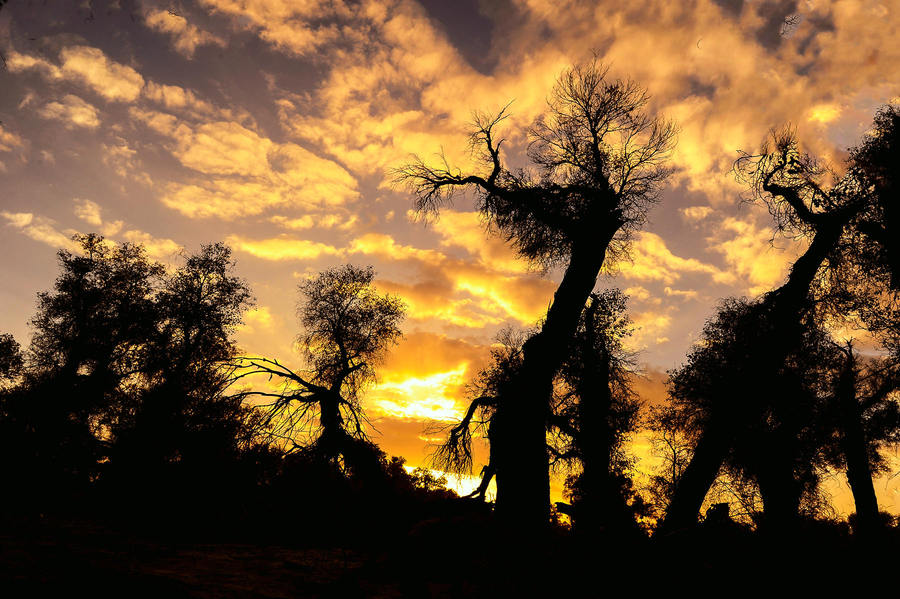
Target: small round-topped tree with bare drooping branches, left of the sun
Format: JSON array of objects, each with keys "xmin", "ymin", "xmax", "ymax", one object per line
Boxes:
[{"xmin": 236, "ymin": 265, "xmax": 405, "ymax": 470}]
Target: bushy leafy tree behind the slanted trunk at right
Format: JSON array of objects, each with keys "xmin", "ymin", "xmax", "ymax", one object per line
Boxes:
[{"xmin": 662, "ymin": 300, "xmax": 836, "ymax": 523}]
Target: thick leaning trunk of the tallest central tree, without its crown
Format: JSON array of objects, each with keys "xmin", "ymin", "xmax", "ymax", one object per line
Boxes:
[{"xmin": 497, "ymin": 219, "xmax": 621, "ymax": 531}]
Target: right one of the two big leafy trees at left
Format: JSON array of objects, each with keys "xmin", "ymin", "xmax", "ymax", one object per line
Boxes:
[{"xmin": 114, "ymin": 243, "xmax": 252, "ymax": 477}]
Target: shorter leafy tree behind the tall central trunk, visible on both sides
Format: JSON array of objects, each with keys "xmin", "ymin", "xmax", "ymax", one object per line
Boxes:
[{"xmin": 433, "ymin": 290, "xmax": 640, "ymax": 534}]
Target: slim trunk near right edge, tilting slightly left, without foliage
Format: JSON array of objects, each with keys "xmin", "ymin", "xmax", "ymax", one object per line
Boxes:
[{"xmin": 837, "ymin": 353, "xmax": 878, "ymax": 534}]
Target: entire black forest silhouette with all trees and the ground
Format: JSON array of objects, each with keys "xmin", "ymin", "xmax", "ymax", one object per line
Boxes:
[{"xmin": 0, "ymin": 61, "xmax": 900, "ymax": 596}]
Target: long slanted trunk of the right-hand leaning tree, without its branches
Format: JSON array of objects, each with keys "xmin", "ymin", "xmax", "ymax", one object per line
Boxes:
[{"xmin": 658, "ymin": 219, "xmax": 844, "ymax": 534}]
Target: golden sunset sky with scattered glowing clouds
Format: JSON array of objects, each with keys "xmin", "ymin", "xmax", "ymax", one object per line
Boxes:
[{"xmin": 0, "ymin": 0, "xmax": 900, "ymax": 511}]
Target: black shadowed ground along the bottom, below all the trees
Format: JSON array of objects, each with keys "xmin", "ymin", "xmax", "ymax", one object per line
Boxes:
[{"xmin": 0, "ymin": 517, "xmax": 900, "ymax": 598}]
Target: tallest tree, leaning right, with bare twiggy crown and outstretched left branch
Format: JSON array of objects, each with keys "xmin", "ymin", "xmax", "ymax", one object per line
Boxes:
[{"xmin": 397, "ymin": 59, "xmax": 676, "ymax": 528}]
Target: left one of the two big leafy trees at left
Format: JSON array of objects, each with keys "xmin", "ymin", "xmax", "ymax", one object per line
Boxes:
[{"xmin": 14, "ymin": 234, "xmax": 164, "ymax": 482}]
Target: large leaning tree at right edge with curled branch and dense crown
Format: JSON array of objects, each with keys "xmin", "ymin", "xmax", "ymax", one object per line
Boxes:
[{"xmin": 662, "ymin": 107, "xmax": 900, "ymax": 531}]
